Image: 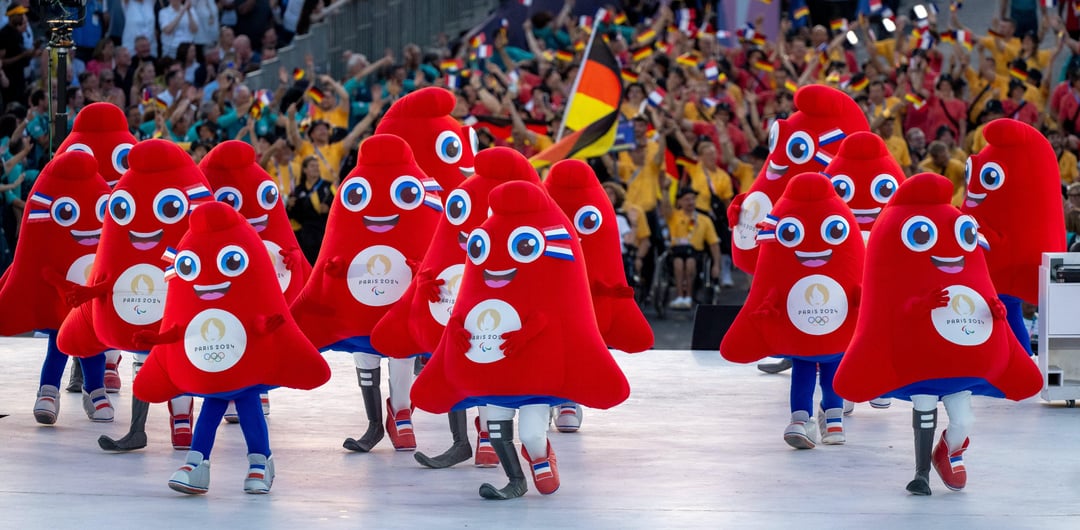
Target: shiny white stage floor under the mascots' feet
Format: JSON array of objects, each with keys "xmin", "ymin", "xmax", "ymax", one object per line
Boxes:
[{"xmin": 0, "ymin": 339, "xmax": 1080, "ymax": 530}]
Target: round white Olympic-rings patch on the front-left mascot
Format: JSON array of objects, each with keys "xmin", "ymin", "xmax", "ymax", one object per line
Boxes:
[{"xmin": 184, "ymin": 309, "xmax": 247, "ymax": 373}]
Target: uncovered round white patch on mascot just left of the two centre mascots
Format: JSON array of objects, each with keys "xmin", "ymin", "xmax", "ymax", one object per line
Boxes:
[{"xmin": 348, "ymin": 245, "xmax": 413, "ymax": 308}]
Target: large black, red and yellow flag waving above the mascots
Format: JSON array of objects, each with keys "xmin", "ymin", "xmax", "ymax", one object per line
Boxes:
[{"xmin": 530, "ymin": 39, "xmax": 622, "ymax": 168}]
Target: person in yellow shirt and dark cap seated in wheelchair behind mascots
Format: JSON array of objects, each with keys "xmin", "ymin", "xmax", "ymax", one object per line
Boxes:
[{"xmin": 667, "ymin": 187, "xmax": 720, "ymax": 309}]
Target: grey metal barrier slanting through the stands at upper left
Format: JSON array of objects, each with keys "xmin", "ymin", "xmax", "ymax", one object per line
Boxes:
[{"xmin": 244, "ymin": 0, "xmax": 499, "ymax": 91}]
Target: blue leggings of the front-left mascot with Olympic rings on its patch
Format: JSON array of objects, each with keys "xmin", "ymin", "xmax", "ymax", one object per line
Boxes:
[{"xmin": 191, "ymin": 389, "xmax": 270, "ymax": 460}]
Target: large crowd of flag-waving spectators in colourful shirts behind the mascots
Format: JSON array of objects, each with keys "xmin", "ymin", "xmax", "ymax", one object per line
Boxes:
[{"xmin": 0, "ymin": 0, "xmax": 1080, "ymax": 307}]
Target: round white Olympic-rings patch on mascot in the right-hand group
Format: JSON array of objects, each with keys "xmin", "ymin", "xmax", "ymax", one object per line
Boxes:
[{"xmin": 787, "ymin": 274, "xmax": 848, "ymax": 335}]
